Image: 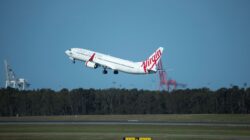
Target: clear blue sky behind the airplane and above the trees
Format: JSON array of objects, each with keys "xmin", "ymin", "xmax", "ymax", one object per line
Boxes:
[{"xmin": 0, "ymin": 0, "xmax": 250, "ymax": 90}]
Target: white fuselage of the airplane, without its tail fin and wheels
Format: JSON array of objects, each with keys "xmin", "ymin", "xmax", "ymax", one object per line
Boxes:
[{"xmin": 65, "ymin": 48, "xmax": 164, "ymax": 74}]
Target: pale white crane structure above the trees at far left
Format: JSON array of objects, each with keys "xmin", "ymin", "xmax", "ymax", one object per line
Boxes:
[{"xmin": 4, "ymin": 60, "xmax": 30, "ymax": 90}]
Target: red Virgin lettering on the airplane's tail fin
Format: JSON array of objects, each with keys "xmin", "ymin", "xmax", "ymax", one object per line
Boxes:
[{"xmin": 141, "ymin": 50, "xmax": 161, "ymax": 73}]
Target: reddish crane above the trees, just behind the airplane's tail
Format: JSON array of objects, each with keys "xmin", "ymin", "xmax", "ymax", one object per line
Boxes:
[{"xmin": 157, "ymin": 59, "xmax": 186, "ymax": 91}]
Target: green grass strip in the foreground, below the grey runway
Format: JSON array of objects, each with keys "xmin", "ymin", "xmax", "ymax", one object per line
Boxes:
[{"xmin": 0, "ymin": 125, "xmax": 250, "ymax": 140}]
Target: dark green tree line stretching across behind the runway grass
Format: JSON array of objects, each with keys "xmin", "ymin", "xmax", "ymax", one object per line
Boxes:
[{"xmin": 0, "ymin": 86, "xmax": 250, "ymax": 116}]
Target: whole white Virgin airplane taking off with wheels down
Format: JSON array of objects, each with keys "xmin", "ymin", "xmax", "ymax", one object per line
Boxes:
[{"xmin": 65, "ymin": 47, "xmax": 163, "ymax": 74}]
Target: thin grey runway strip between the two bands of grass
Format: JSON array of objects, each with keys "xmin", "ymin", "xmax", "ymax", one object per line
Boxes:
[{"xmin": 0, "ymin": 120, "xmax": 250, "ymax": 127}]
